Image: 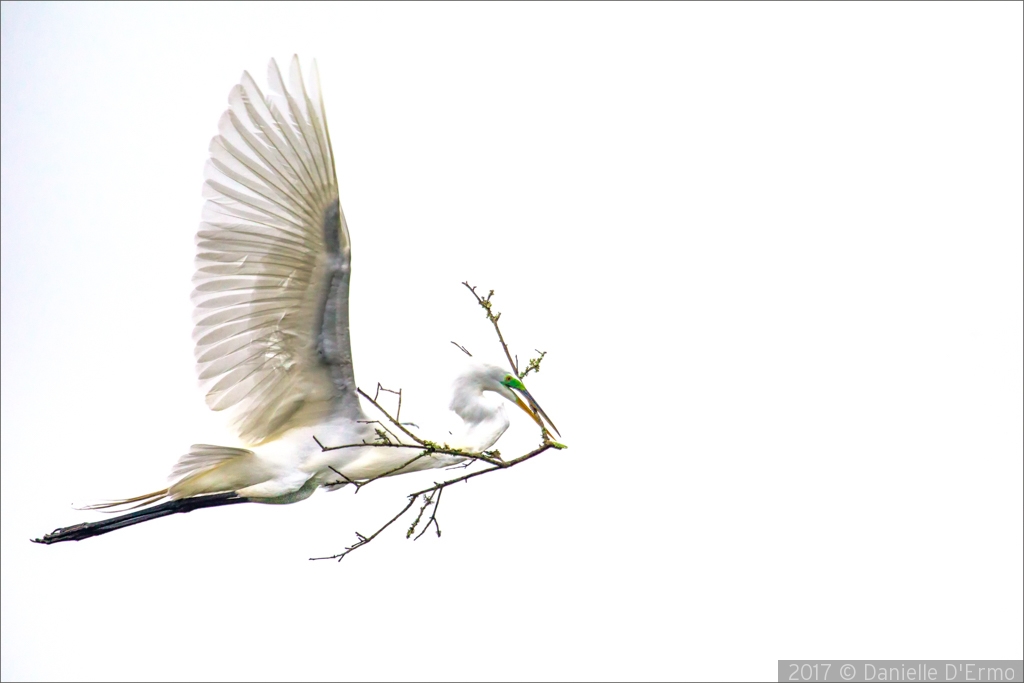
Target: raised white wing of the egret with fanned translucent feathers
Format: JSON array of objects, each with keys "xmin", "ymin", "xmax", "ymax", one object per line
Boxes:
[{"xmin": 193, "ymin": 57, "xmax": 359, "ymax": 443}]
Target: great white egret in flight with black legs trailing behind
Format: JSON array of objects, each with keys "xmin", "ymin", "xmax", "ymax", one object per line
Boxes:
[{"xmin": 32, "ymin": 56, "xmax": 557, "ymax": 543}]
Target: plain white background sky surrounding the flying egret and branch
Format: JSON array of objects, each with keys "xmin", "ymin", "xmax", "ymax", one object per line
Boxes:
[{"xmin": 2, "ymin": 3, "xmax": 1024, "ymax": 680}]
